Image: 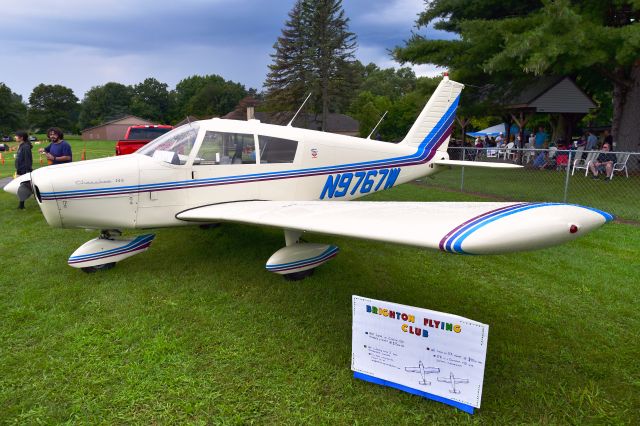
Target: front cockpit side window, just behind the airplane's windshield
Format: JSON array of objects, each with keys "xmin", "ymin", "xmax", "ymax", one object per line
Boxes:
[{"xmin": 193, "ymin": 131, "xmax": 256, "ymax": 165}]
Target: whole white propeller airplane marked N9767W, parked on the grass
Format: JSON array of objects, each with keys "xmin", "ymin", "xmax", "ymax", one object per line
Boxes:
[{"xmin": 5, "ymin": 76, "xmax": 613, "ymax": 279}]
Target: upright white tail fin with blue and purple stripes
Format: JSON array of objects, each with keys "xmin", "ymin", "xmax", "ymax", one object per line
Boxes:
[{"xmin": 400, "ymin": 75, "xmax": 464, "ymax": 152}]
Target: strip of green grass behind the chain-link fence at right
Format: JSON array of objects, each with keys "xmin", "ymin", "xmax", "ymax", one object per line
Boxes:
[{"xmin": 424, "ymin": 167, "xmax": 640, "ymax": 221}]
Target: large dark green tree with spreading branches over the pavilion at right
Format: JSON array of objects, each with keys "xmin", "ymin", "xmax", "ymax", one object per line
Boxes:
[{"xmin": 395, "ymin": 0, "xmax": 640, "ymax": 151}]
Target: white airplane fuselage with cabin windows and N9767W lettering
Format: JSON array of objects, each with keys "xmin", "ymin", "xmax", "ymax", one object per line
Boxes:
[{"xmin": 31, "ymin": 119, "xmax": 450, "ymax": 229}]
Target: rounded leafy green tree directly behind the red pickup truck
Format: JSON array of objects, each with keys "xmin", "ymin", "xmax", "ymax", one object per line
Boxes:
[{"xmin": 130, "ymin": 78, "xmax": 170, "ymax": 123}]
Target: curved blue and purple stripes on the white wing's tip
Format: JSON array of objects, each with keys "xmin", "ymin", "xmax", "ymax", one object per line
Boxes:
[{"xmin": 439, "ymin": 203, "xmax": 613, "ymax": 254}]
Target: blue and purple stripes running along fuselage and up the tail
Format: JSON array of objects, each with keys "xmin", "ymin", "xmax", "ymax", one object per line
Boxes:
[{"xmin": 41, "ymin": 96, "xmax": 460, "ymax": 200}]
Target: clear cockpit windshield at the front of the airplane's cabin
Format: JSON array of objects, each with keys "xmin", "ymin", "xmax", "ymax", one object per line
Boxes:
[{"xmin": 136, "ymin": 123, "xmax": 200, "ymax": 165}]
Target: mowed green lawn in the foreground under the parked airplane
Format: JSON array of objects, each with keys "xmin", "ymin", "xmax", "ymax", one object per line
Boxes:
[{"xmin": 0, "ymin": 184, "xmax": 640, "ymax": 424}]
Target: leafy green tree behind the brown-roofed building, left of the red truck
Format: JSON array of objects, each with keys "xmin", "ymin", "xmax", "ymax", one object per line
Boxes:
[{"xmin": 80, "ymin": 82, "xmax": 133, "ymax": 128}]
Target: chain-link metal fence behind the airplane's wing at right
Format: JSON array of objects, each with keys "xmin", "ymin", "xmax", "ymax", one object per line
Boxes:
[{"xmin": 424, "ymin": 147, "xmax": 640, "ymax": 222}]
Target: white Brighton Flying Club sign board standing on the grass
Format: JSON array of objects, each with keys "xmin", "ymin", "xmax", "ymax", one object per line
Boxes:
[{"xmin": 351, "ymin": 296, "xmax": 489, "ymax": 413}]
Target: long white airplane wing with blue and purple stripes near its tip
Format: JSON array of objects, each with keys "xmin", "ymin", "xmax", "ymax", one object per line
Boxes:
[{"xmin": 176, "ymin": 201, "xmax": 613, "ymax": 254}]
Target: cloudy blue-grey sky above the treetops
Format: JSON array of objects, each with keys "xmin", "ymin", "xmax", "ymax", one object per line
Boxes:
[{"xmin": 0, "ymin": 0, "xmax": 449, "ymax": 100}]
